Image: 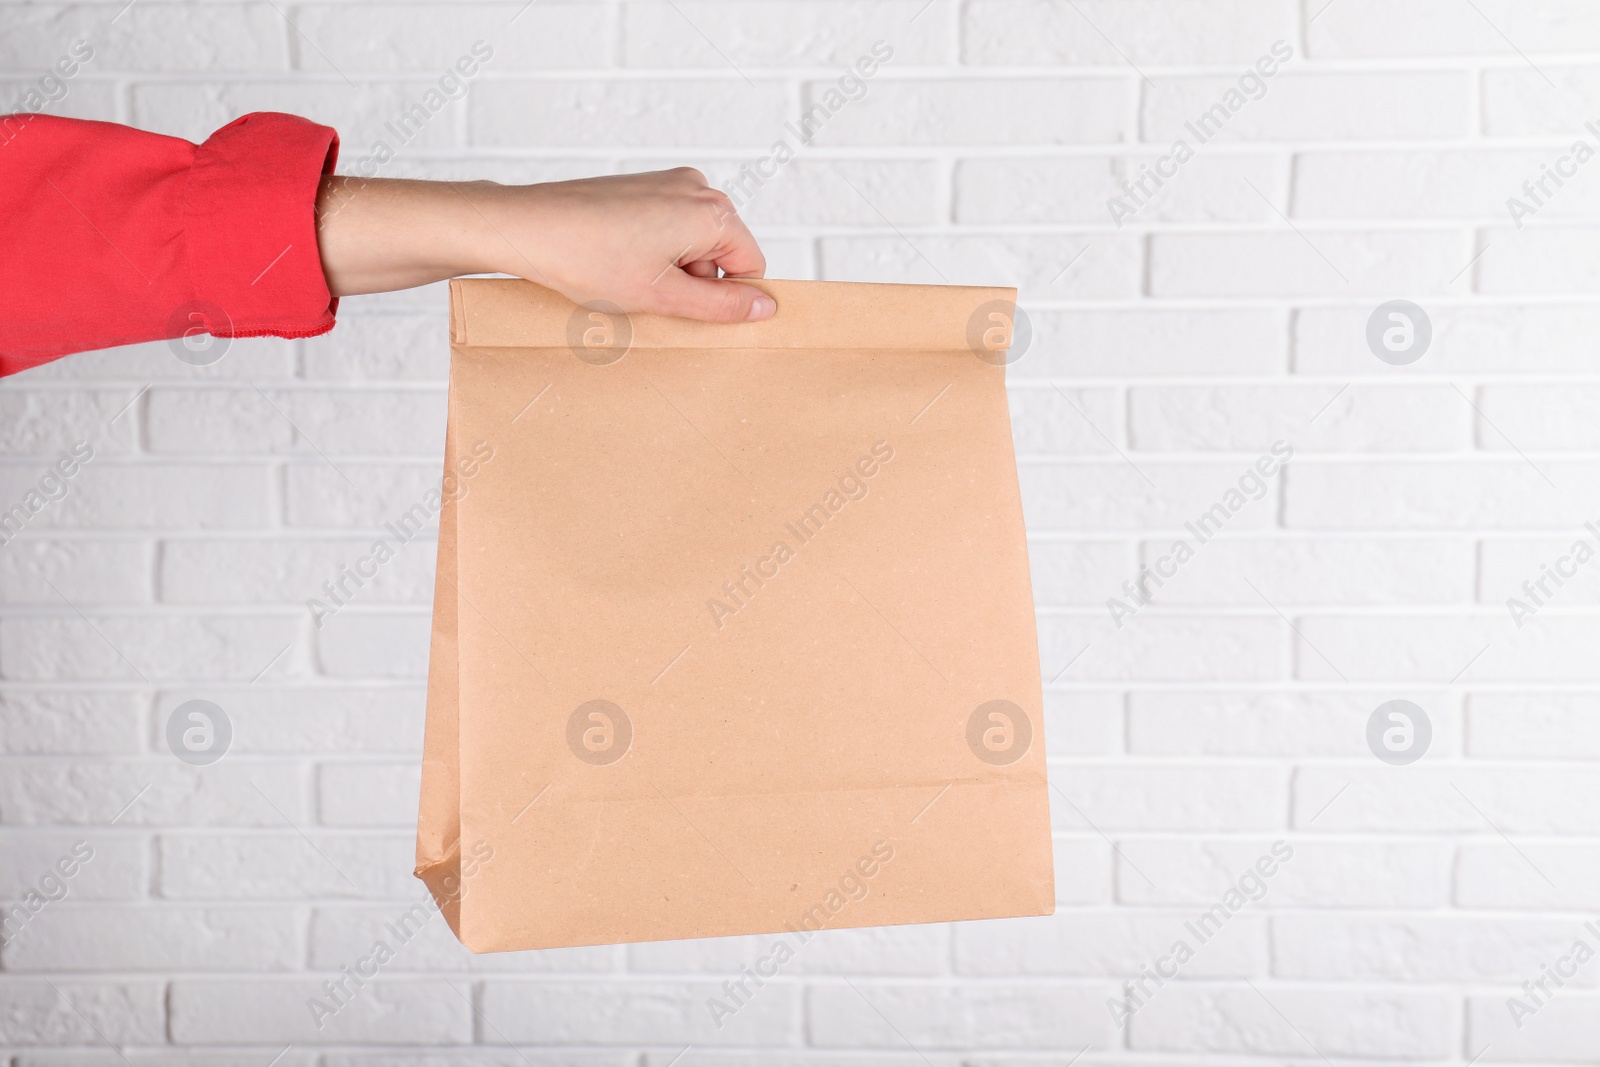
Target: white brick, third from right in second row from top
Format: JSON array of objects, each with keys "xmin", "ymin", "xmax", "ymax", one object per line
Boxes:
[{"xmin": 806, "ymin": 75, "xmax": 1136, "ymax": 147}]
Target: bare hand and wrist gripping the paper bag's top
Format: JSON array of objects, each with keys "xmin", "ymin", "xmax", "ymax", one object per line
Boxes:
[{"xmin": 317, "ymin": 166, "xmax": 776, "ymax": 322}]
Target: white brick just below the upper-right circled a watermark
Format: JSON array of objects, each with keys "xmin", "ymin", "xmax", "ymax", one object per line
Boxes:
[{"xmin": 1128, "ymin": 386, "xmax": 1472, "ymax": 453}]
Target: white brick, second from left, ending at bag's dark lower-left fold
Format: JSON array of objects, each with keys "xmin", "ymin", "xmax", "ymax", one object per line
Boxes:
[{"xmin": 158, "ymin": 831, "xmax": 418, "ymax": 901}]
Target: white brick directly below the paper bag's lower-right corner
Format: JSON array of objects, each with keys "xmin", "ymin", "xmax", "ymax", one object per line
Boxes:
[{"xmin": 954, "ymin": 910, "xmax": 1267, "ymax": 979}]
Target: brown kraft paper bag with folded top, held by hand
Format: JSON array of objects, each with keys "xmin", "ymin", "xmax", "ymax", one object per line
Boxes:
[{"xmin": 416, "ymin": 280, "xmax": 1054, "ymax": 952}]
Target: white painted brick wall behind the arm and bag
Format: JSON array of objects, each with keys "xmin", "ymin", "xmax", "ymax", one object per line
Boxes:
[{"xmin": 9, "ymin": 0, "xmax": 1600, "ymax": 1067}]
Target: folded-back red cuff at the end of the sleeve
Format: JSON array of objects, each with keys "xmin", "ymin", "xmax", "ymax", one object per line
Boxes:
[{"xmin": 184, "ymin": 112, "xmax": 339, "ymax": 338}]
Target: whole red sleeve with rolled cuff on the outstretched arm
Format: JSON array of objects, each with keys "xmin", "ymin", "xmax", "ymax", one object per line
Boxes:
[{"xmin": 0, "ymin": 112, "xmax": 339, "ymax": 374}]
